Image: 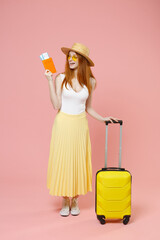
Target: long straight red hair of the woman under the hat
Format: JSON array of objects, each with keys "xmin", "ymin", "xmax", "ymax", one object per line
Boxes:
[{"xmin": 61, "ymin": 52, "xmax": 97, "ymax": 95}]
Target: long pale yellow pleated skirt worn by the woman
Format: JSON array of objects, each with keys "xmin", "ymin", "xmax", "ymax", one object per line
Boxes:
[{"xmin": 47, "ymin": 111, "xmax": 92, "ymax": 197}]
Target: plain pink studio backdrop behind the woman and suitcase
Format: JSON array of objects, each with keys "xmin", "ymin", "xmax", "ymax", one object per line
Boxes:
[{"xmin": 0, "ymin": 0, "xmax": 160, "ymax": 240}]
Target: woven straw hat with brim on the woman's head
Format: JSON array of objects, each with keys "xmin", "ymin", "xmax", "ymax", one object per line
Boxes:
[{"xmin": 61, "ymin": 43, "xmax": 94, "ymax": 66}]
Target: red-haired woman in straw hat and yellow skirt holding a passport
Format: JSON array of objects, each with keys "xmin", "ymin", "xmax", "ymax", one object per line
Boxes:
[{"xmin": 45, "ymin": 43, "xmax": 118, "ymax": 216}]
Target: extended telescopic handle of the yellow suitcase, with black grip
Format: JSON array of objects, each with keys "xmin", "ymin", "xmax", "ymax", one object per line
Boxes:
[{"xmin": 105, "ymin": 119, "xmax": 123, "ymax": 168}]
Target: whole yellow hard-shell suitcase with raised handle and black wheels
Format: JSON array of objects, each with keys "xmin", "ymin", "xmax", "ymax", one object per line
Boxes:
[{"xmin": 95, "ymin": 120, "xmax": 132, "ymax": 224}]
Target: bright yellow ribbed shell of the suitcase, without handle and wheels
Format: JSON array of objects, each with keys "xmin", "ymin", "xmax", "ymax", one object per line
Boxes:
[{"xmin": 96, "ymin": 171, "xmax": 131, "ymax": 219}]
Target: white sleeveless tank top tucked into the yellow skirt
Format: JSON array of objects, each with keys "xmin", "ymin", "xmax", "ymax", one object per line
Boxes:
[{"xmin": 60, "ymin": 73, "xmax": 89, "ymax": 114}]
